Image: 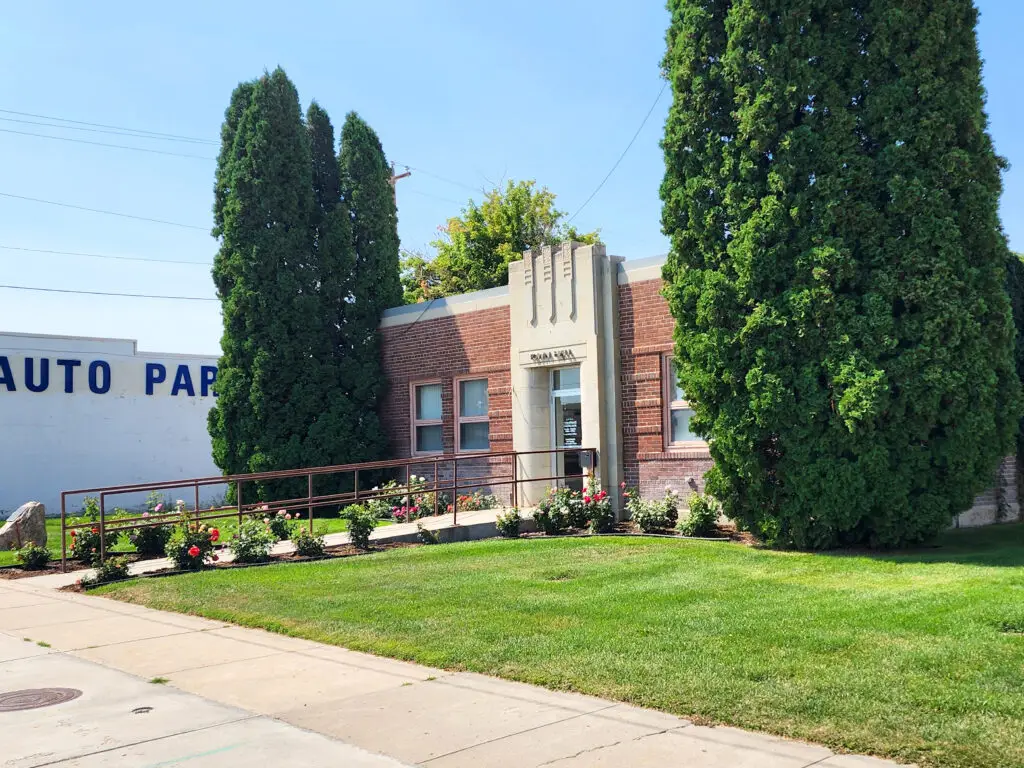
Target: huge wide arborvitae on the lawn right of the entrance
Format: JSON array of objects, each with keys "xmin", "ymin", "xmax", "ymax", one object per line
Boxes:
[{"xmin": 662, "ymin": 0, "xmax": 1019, "ymax": 548}]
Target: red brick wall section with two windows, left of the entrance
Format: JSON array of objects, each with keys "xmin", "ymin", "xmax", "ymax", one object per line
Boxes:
[{"xmin": 380, "ymin": 306, "xmax": 512, "ymax": 505}]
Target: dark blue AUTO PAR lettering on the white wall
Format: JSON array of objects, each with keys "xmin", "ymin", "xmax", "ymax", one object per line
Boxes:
[{"xmin": 0, "ymin": 354, "xmax": 217, "ymax": 397}]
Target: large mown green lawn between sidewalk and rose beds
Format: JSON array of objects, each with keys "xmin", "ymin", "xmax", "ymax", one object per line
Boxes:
[{"xmin": 101, "ymin": 525, "xmax": 1024, "ymax": 768}]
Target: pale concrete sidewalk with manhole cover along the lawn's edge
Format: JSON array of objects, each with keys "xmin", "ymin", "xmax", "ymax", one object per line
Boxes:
[{"xmin": 0, "ymin": 579, "xmax": 895, "ymax": 768}]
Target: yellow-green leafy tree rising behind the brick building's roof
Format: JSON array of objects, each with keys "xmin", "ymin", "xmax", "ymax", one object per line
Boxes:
[{"xmin": 402, "ymin": 180, "xmax": 599, "ymax": 303}]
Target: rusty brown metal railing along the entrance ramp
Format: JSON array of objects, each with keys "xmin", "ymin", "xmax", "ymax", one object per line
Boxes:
[{"xmin": 60, "ymin": 447, "xmax": 597, "ymax": 571}]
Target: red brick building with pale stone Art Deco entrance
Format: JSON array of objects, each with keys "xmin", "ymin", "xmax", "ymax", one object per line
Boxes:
[{"xmin": 381, "ymin": 244, "xmax": 711, "ymax": 514}]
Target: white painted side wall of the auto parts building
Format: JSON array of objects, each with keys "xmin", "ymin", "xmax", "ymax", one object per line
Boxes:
[{"xmin": 0, "ymin": 333, "xmax": 223, "ymax": 519}]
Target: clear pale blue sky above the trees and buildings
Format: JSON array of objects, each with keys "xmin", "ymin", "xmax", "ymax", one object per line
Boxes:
[{"xmin": 0, "ymin": 0, "xmax": 1024, "ymax": 353}]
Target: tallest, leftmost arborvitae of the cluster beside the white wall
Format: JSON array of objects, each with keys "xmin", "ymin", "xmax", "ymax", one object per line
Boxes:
[{"xmin": 209, "ymin": 69, "xmax": 325, "ymax": 493}]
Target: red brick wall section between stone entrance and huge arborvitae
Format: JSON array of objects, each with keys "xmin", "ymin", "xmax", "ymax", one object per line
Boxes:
[{"xmin": 618, "ymin": 280, "xmax": 712, "ymax": 498}]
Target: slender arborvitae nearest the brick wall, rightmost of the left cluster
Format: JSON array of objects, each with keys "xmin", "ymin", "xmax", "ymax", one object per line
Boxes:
[{"xmin": 338, "ymin": 112, "xmax": 402, "ymax": 442}]
